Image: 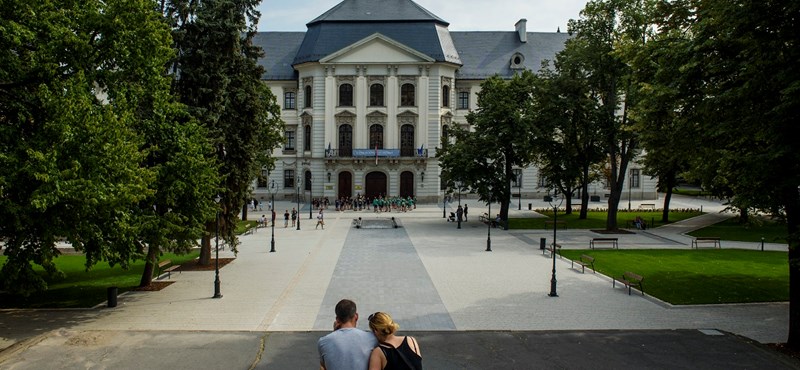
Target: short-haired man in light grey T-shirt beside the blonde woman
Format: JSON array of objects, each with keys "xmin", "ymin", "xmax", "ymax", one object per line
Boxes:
[{"xmin": 317, "ymin": 299, "xmax": 378, "ymax": 370}]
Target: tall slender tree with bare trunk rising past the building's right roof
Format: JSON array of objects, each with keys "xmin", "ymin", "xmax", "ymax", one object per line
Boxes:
[{"xmin": 566, "ymin": 0, "xmax": 649, "ymax": 230}]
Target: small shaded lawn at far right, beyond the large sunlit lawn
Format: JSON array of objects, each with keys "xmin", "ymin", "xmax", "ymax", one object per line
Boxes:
[{"xmin": 689, "ymin": 218, "xmax": 787, "ymax": 243}]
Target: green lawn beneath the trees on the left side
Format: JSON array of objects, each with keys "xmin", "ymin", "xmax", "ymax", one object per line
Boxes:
[{"xmin": 0, "ymin": 252, "xmax": 199, "ymax": 308}]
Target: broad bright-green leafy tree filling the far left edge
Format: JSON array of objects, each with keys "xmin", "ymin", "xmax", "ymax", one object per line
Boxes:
[{"xmin": 0, "ymin": 1, "xmax": 197, "ymax": 294}]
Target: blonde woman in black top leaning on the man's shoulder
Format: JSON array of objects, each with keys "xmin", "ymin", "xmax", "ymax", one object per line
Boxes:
[{"xmin": 369, "ymin": 312, "xmax": 422, "ymax": 370}]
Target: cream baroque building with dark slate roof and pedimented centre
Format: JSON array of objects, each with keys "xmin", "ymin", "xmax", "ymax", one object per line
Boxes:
[{"xmin": 253, "ymin": 0, "xmax": 656, "ymax": 202}]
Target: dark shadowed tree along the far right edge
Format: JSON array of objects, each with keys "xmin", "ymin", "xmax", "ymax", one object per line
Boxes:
[{"xmin": 665, "ymin": 0, "xmax": 800, "ymax": 348}]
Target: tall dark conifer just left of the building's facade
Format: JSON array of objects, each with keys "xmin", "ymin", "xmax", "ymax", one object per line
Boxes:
[{"xmin": 161, "ymin": 0, "xmax": 283, "ymax": 265}]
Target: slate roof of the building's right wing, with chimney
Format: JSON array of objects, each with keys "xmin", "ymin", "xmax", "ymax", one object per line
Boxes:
[{"xmin": 450, "ymin": 31, "xmax": 570, "ymax": 80}]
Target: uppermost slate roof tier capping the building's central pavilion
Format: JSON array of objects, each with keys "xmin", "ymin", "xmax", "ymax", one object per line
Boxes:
[{"xmin": 307, "ymin": 0, "xmax": 449, "ymax": 27}]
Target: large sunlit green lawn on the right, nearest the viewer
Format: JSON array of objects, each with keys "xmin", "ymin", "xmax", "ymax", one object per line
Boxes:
[{"xmin": 562, "ymin": 249, "xmax": 789, "ymax": 305}]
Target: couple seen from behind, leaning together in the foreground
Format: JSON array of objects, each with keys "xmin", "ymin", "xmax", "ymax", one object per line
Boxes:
[{"xmin": 317, "ymin": 299, "xmax": 422, "ymax": 370}]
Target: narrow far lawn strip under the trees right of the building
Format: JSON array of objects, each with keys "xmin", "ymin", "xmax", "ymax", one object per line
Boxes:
[{"xmin": 508, "ymin": 210, "xmax": 702, "ymax": 230}]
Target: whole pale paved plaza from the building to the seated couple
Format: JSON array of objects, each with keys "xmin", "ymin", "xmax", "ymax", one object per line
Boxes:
[{"xmin": 0, "ymin": 197, "xmax": 796, "ymax": 369}]
